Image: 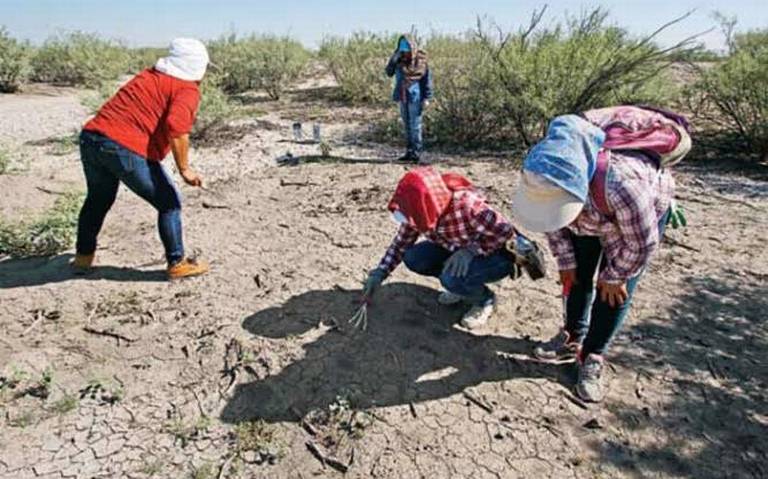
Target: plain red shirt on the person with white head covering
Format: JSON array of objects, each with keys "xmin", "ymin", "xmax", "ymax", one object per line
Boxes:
[{"xmin": 83, "ymin": 68, "xmax": 200, "ymax": 161}]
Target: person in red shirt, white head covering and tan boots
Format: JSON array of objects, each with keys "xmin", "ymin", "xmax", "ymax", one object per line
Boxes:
[{"xmin": 73, "ymin": 38, "xmax": 209, "ymax": 279}]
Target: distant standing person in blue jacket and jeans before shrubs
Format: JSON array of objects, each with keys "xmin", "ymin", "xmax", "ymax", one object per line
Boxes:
[{"xmin": 386, "ymin": 35, "xmax": 432, "ymax": 163}]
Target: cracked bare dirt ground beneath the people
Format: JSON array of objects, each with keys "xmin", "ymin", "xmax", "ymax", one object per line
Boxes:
[{"xmin": 0, "ymin": 79, "xmax": 768, "ymax": 479}]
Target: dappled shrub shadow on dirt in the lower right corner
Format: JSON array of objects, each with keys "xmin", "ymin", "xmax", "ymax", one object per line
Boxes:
[{"xmin": 600, "ymin": 270, "xmax": 768, "ymax": 479}]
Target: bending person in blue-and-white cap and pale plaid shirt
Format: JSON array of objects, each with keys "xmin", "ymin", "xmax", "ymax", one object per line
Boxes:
[{"xmin": 513, "ymin": 115, "xmax": 674, "ymax": 402}]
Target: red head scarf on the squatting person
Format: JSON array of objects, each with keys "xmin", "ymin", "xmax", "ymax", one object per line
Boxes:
[{"xmin": 388, "ymin": 166, "xmax": 472, "ymax": 233}]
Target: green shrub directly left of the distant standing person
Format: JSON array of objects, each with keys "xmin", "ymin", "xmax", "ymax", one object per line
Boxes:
[{"xmin": 319, "ymin": 32, "xmax": 397, "ymax": 104}]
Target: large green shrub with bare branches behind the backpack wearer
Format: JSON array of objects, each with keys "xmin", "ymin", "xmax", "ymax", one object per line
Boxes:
[{"xmin": 464, "ymin": 9, "xmax": 689, "ymax": 146}]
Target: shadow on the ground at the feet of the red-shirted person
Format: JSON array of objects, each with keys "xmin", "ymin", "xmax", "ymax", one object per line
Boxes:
[{"xmin": 0, "ymin": 254, "xmax": 167, "ymax": 289}]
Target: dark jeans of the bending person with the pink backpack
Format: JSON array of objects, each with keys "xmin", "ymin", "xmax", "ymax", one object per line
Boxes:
[{"xmin": 565, "ymin": 212, "xmax": 669, "ymax": 357}]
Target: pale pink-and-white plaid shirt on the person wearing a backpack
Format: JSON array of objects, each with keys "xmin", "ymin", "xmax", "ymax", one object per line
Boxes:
[{"xmin": 547, "ymin": 152, "xmax": 675, "ymax": 283}]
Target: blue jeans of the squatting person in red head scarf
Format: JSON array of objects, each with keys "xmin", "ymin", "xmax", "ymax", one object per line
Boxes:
[{"xmin": 403, "ymin": 241, "xmax": 513, "ymax": 306}]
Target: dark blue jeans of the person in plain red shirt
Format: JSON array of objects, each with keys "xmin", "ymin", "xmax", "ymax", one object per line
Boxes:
[{"xmin": 76, "ymin": 131, "xmax": 184, "ymax": 265}]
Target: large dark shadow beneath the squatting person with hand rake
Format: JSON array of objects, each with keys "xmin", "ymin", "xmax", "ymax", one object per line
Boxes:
[{"xmin": 221, "ymin": 283, "xmax": 567, "ymax": 423}]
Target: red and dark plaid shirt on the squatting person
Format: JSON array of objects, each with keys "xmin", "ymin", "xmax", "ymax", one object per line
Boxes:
[{"xmin": 379, "ymin": 190, "xmax": 515, "ymax": 274}]
